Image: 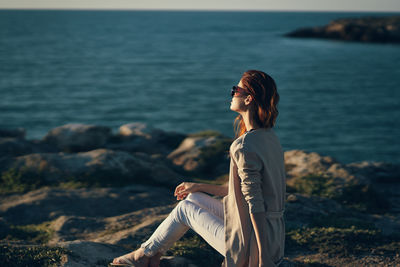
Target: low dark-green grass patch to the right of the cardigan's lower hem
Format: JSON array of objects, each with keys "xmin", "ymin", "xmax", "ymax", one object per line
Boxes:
[{"xmin": 286, "ymin": 226, "xmax": 400, "ymax": 257}]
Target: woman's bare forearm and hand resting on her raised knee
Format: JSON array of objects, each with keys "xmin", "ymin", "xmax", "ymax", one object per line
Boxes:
[{"xmin": 174, "ymin": 182, "xmax": 228, "ymax": 200}]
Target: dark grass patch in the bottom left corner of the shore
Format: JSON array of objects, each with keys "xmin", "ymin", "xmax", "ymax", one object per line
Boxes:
[{"xmin": 0, "ymin": 245, "xmax": 69, "ymax": 267}]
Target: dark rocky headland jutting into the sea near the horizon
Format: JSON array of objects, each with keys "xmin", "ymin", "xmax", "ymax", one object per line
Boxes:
[{"xmin": 286, "ymin": 16, "xmax": 400, "ymax": 43}]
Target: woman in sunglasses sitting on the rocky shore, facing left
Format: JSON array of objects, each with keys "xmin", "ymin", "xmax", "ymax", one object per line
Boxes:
[{"xmin": 111, "ymin": 70, "xmax": 286, "ymax": 267}]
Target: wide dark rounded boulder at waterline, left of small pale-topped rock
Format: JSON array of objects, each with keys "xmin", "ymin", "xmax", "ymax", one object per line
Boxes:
[{"xmin": 42, "ymin": 123, "xmax": 111, "ymax": 152}]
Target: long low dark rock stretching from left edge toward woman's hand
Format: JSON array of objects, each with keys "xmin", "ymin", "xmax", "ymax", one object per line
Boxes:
[{"xmin": 1, "ymin": 149, "xmax": 182, "ymax": 186}]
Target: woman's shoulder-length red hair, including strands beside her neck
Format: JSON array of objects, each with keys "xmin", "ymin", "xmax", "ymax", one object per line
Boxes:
[{"xmin": 233, "ymin": 70, "xmax": 279, "ymax": 138}]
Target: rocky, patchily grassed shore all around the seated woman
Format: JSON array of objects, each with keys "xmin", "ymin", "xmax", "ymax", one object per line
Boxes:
[{"xmin": 0, "ymin": 123, "xmax": 400, "ymax": 266}]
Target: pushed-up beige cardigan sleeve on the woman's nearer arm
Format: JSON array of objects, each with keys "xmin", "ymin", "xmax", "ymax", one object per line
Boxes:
[{"xmin": 234, "ymin": 147, "xmax": 265, "ymax": 213}]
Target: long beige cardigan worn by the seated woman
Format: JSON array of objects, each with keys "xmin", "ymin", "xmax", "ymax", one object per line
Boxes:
[{"xmin": 222, "ymin": 128, "xmax": 286, "ymax": 267}]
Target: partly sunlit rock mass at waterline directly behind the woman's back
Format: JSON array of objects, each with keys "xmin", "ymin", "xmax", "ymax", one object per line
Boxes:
[{"xmin": 285, "ymin": 150, "xmax": 400, "ymax": 214}]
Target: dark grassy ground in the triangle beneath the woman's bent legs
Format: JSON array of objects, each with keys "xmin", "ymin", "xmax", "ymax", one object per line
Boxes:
[{"xmin": 166, "ymin": 230, "xmax": 224, "ymax": 266}]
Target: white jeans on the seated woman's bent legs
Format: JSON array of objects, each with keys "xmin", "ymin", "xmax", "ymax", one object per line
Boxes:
[{"xmin": 140, "ymin": 192, "xmax": 225, "ymax": 257}]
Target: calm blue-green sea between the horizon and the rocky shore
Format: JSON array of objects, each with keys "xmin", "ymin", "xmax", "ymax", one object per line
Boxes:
[{"xmin": 0, "ymin": 10, "xmax": 400, "ymax": 163}]
